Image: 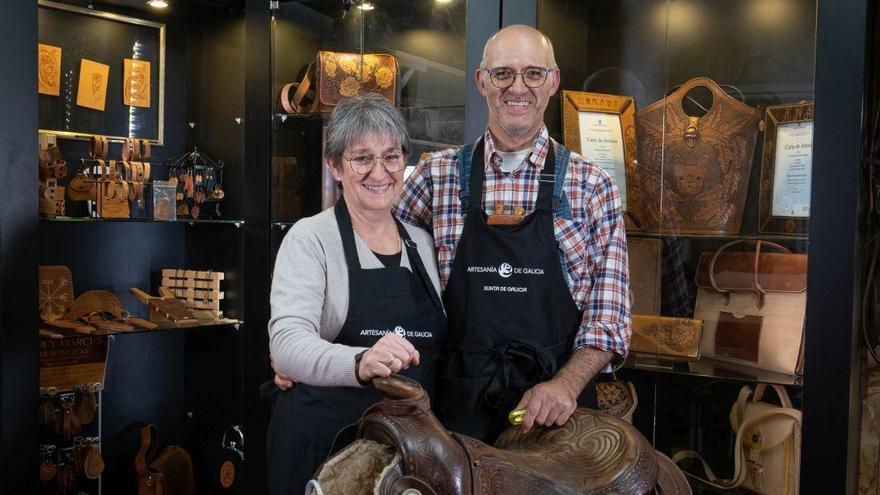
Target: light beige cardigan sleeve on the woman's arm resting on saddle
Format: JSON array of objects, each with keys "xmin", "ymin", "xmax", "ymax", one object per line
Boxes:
[{"xmin": 269, "ymin": 226, "xmax": 363, "ymax": 387}]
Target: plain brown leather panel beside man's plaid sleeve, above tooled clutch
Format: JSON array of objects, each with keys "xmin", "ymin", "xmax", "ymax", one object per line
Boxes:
[{"xmin": 626, "ymin": 237, "xmax": 663, "ymax": 315}]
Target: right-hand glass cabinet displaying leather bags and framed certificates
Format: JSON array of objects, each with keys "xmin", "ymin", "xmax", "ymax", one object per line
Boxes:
[{"xmin": 537, "ymin": 0, "xmax": 816, "ymax": 493}]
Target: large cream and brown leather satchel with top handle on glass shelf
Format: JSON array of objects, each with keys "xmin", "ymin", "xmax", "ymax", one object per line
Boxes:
[{"xmin": 694, "ymin": 240, "xmax": 807, "ymax": 375}]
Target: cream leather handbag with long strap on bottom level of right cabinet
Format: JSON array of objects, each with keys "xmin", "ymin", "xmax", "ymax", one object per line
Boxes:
[{"xmin": 672, "ymin": 383, "xmax": 801, "ymax": 495}]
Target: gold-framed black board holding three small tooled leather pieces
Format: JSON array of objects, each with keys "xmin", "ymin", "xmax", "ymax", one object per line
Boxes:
[{"xmin": 38, "ymin": 0, "xmax": 166, "ymax": 146}]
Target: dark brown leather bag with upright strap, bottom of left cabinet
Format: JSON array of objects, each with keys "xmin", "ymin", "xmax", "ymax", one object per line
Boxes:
[{"xmin": 134, "ymin": 425, "xmax": 196, "ymax": 495}]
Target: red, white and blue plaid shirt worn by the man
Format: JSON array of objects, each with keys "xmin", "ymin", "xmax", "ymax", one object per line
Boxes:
[{"xmin": 394, "ymin": 127, "xmax": 632, "ymax": 367}]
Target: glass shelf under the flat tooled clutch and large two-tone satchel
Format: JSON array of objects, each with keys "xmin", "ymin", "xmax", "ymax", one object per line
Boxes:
[{"xmin": 623, "ymin": 354, "xmax": 804, "ymax": 387}]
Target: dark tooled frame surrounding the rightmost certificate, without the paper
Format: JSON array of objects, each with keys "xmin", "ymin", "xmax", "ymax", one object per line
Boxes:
[{"xmin": 758, "ymin": 102, "xmax": 813, "ymax": 235}]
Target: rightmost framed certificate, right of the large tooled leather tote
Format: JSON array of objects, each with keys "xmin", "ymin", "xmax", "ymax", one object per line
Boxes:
[{"xmin": 758, "ymin": 102, "xmax": 813, "ymax": 235}]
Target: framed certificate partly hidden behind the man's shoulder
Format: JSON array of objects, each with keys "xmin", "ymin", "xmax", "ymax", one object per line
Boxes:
[{"xmin": 562, "ymin": 90, "xmax": 640, "ymax": 230}]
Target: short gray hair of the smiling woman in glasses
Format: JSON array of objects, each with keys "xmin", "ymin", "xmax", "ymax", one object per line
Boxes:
[{"xmin": 324, "ymin": 93, "xmax": 410, "ymax": 163}]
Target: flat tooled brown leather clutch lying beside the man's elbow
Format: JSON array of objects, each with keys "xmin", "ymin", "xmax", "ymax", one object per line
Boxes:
[{"xmin": 630, "ymin": 315, "xmax": 703, "ymax": 361}]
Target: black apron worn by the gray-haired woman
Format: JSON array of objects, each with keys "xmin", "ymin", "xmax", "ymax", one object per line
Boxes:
[{"xmin": 267, "ymin": 199, "xmax": 446, "ymax": 495}]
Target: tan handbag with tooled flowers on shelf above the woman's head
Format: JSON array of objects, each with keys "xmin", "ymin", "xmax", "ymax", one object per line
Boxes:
[{"xmin": 281, "ymin": 50, "xmax": 398, "ymax": 113}]
